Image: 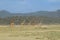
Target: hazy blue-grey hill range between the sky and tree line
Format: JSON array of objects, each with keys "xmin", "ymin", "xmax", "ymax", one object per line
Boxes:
[{"xmin": 0, "ymin": 10, "xmax": 60, "ymax": 17}]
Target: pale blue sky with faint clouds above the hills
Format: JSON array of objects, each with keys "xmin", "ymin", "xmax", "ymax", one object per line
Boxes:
[{"xmin": 0, "ymin": 0, "xmax": 60, "ymax": 13}]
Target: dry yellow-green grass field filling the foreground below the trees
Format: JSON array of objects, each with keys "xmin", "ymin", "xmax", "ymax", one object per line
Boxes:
[{"xmin": 0, "ymin": 25, "xmax": 60, "ymax": 40}]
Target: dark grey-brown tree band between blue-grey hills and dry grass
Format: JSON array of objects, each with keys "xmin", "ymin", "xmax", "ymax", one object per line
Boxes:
[{"xmin": 0, "ymin": 16, "xmax": 60, "ymax": 25}]
